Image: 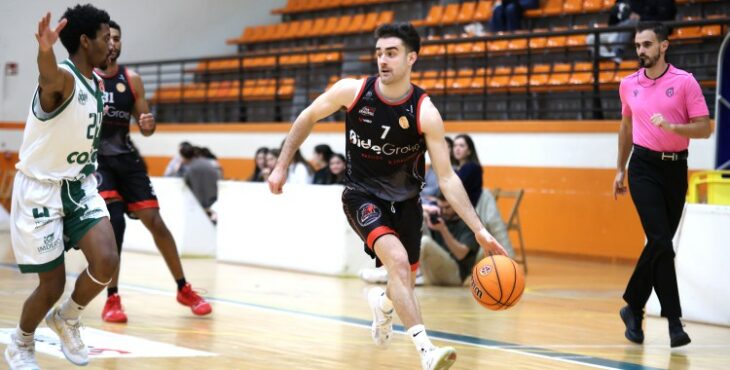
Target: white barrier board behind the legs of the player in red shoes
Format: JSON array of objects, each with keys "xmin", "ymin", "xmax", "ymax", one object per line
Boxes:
[{"xmin": 122, "ymin": 177, "xmax": 217, "ymax": 257}]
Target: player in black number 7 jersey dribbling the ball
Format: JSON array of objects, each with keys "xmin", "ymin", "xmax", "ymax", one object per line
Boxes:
[{"xmin": 268, "ymin": 23, "xmax": 506, "ymax": 370}]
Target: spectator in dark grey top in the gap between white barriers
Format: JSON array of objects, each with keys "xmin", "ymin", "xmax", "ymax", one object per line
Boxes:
[{"xmin": 180, "ymin": 146, "xmax": 220, "ymax": 217}]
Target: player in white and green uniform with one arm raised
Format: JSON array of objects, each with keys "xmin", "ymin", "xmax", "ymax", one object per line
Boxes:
[{"xmin": 5, "ymin": 5, "xmax": 119, "ymax": 369}]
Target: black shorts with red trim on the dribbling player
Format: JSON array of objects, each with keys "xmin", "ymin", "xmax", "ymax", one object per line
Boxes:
[{"xmin": 342, "ymin": 187, "xmax": 423, "ymax": 271}]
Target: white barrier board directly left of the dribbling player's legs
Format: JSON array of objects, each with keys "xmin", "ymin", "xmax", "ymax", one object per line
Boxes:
[{"xmin": 216, "ymin": 181, "xmax": 374, "ymax": 276}]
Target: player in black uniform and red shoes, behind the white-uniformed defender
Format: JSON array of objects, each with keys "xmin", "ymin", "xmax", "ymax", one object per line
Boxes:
[{"xmin": 97, "ymin": 21, "xmax": 212, "ymax": 323}]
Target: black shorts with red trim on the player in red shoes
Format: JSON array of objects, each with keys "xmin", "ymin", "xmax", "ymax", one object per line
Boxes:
[{"xmin": 96, "ymin": 152, "xmax": 160, "ymax": 212}]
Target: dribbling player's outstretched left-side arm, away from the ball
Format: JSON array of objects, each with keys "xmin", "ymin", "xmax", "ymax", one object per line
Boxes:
[{"xmin": 267, "ymin": 78, "xmax": 362, "ymax": 194}]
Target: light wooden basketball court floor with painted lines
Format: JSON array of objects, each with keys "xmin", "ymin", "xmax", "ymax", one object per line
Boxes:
[{"xmin": 0, "ymin": 233, "xmax": 730, "ymax": 370}]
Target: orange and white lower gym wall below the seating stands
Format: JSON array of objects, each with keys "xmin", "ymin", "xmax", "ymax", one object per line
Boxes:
[{"xmin": 0, "ymin": 121, "xmax": 715, "ymax": 259}]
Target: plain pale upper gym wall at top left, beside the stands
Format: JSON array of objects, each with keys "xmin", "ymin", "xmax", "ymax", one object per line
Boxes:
[{"xmin": 0, "ymin": 0, "xmax": 286, "ymax": 121}]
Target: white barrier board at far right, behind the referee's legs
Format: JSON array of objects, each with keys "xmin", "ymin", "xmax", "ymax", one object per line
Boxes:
[{"xmin": 646, "ymin": 204, "xmax": 730, "ymax": 326}]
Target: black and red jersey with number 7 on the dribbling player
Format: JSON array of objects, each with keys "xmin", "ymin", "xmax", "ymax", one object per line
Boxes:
[{"xmin": 345, "ymin": 76, "xmax": 427, "ymax": 202}]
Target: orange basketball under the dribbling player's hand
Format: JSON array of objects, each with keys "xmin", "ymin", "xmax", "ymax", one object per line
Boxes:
[{"xmin": 471, "ymin": 256, "xmax": 525, "ymax": 311}]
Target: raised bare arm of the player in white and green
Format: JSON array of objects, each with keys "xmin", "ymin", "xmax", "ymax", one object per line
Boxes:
[{"xmin": 35, "ymin": 13, "xmax": 74, "ymax": 112}]
